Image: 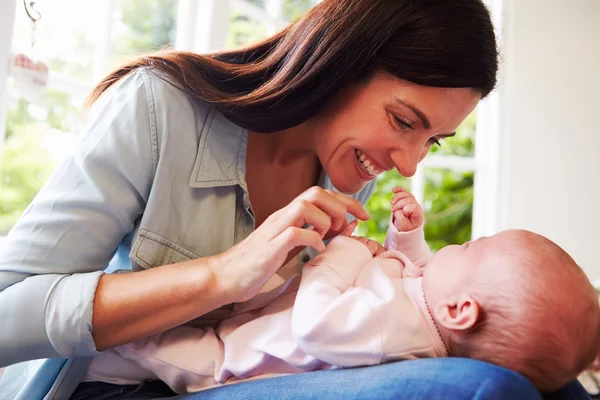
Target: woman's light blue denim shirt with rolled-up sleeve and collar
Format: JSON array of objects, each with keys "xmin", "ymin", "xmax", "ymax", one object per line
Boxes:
[{"xmin": 0, "ymin": 69, "xmax": 373, "ymax": 400}]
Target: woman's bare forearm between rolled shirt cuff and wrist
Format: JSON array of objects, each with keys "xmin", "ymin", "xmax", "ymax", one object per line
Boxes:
[{"xmin": 92, "ymin": 258, "xmax": 227, "ymax": 351}]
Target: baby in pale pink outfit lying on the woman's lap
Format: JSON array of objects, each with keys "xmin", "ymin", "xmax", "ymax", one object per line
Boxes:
[{"xmin": 86, "ymin": 188, "xmax": 600, "ymax": 393}]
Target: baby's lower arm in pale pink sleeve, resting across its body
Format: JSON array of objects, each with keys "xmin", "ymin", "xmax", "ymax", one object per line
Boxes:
[{"xmin": 292, "ymin": 236, "xmax": 382, "ymax": 367}]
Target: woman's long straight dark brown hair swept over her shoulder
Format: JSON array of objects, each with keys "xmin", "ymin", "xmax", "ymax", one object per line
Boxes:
[{"xmin": 88, "ymin": 0, "xmax": 498, "ymax": 133}]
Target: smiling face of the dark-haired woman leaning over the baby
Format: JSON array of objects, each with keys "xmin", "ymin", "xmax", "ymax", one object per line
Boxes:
[{"xmin": 313, "ymin": 71, "xmax": 481, "ymax": 193}]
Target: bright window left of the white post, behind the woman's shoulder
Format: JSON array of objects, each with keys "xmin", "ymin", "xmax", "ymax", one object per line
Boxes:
[{"xmin": 0, "ymin": 0, "xmax": 177, "ymax": 236}]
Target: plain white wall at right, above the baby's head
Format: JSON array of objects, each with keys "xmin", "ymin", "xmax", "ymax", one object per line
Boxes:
[{"xmin": 499, "ymin": 0, "xmax": 600, "ymax": 280}]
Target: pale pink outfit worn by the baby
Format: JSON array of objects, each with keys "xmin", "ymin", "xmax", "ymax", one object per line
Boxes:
[{"xmin": 86, "ymin": 224, "xmax": 447, "ymax": 393}]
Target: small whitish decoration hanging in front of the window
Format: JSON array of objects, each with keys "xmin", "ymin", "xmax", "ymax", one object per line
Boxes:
[{"xmin": 11, "ymin": 0, "xmax": 49, "ymax": 101}]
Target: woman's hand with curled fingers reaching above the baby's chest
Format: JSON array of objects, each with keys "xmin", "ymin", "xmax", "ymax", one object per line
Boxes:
[{"xmin": 210, "ymin": 187, "xmax": 369, "ymax": 303}]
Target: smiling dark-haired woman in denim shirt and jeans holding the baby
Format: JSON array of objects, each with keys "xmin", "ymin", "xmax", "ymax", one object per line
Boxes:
[{"xmin": 0, "ymin": 0, "xmax": 592, "ymax": 399}]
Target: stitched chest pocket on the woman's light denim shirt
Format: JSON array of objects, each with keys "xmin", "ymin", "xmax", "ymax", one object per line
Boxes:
[{"xmin": 129, "ymin": 229, "xmax": 200, "ymax": 269}]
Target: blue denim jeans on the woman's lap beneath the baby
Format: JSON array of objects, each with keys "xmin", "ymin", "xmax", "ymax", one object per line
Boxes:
[{"xmin": 71, "ymin": 358, "xmax": 589, "ymax": 400}]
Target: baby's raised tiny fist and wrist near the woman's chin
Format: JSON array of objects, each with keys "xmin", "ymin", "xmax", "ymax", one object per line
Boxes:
[{"xmin": 384, "ymin": 187, "xmax": 431, "ymax": 267}]
